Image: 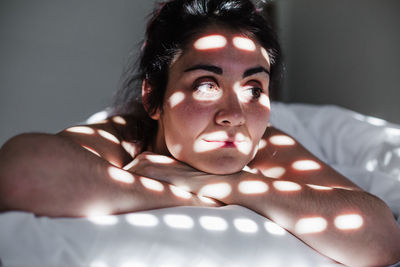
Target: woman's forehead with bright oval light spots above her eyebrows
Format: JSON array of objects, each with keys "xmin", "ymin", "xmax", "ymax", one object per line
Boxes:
[{"xmin": 171, "ymin": 26, "xmax": 270, "ymax": 73}]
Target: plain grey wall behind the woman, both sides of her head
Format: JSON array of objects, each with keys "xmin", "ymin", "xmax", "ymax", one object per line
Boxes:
[{"xmin": 0, "ymin": 0, "xmax": 400, "ymax": 145}]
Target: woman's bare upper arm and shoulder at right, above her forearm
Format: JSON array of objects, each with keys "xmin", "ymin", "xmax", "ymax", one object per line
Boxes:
[{"xmin": 249, "ymin": 126, "xmax": 359, "ymax": 189}]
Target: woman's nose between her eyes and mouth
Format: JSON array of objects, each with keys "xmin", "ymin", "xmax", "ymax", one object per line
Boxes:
[{"xmin": 215, "ymin": 94, "xmax": 246, "ymax": 126}]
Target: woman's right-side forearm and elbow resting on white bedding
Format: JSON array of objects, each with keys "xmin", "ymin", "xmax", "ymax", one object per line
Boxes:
[{"xmin": 220, "ymin": 174, "xmax": 400, "ymax": 266}]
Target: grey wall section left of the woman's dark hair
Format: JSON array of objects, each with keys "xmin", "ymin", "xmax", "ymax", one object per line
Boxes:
[{"xmin": 0, "ymin": 0, "xmax": 154, "ymax": 145}]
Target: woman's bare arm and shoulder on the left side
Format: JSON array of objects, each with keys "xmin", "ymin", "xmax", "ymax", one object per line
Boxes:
[{"xmin": 0, "ymin": 119, "xmax": 216, "ymax": 217}]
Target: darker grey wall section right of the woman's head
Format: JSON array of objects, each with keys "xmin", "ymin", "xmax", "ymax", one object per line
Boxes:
[{"xmin": 277, "ymin": 0, "xmax": 400, "ymax": 123}]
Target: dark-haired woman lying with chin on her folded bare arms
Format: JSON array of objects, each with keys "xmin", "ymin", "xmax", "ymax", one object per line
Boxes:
[{"xmin": 0, "ymin": 0, "xmax": 400, "ymax": 266}]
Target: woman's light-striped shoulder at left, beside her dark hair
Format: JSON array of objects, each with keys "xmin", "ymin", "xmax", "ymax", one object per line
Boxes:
[{"xmin": 57, "ymin": 116, "xmax": 141, "ymax": 167}]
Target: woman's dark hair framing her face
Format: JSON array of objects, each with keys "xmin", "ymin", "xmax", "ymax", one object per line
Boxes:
[{"xmin": 113, "ymin": 0, "xmax": 281, "ymax": 145}]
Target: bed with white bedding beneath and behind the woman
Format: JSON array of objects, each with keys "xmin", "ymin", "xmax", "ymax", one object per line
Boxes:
[{"xmin": 0, "ymin": 102, "xmax": 400, "ymax": 267}]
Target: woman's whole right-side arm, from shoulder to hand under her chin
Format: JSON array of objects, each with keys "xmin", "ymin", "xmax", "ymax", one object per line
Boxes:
[{"xmin": 132, "ymin": 129, "xmax": 400, "ymax": 266}]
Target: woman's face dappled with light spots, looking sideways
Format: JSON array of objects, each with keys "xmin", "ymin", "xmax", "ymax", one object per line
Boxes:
[{"xmin": 153, "ymin": 27, "xmax": 270, "ymax": 174}]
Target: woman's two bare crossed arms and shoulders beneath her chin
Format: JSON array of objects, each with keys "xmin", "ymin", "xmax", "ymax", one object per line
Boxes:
[{"xmin": 0, "ymin": 118, "xmax": 400, "ymax": 266}]
